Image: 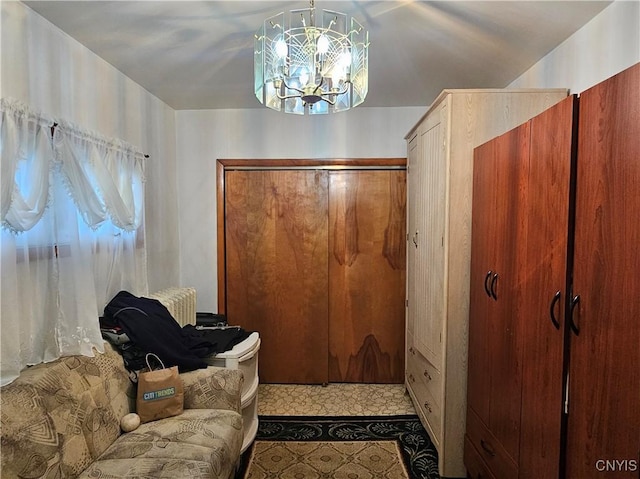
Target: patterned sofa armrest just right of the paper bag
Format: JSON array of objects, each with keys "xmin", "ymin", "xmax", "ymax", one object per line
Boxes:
[{"xmin": 180, "ymin": 366, "xmax": 244, "ymax": 412}]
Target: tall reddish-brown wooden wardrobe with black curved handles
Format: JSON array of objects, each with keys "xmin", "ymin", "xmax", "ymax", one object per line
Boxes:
[{"xmin": 465, "ymin": 64, "xmax": 640, "ymax": 479}]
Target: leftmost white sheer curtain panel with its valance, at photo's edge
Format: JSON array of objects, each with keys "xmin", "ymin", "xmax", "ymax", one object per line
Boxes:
[{"xmin": 0, "ymin": 100, "xmax": 58, "ymax": 384}]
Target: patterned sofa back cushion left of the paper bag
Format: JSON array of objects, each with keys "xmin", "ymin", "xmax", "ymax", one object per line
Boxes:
[{"xmin": 0, "ymin": 344, "xmax": 133, "ymax": 478}]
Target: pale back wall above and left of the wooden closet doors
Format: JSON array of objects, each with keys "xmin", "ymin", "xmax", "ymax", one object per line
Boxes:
[{"xmin": 176, "ymin": 107, "xmax": 426, "ymax": 312}]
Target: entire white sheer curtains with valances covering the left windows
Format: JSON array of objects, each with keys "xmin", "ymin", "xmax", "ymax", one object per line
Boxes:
[{"xmin": 0, "ymin": 100, "xmax": 148, "ymax": 384}]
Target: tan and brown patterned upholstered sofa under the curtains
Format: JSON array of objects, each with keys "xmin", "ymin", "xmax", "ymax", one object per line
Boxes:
[{"xmin": 0, "ymin": 343, "xmax": 243, "ymax": 479}]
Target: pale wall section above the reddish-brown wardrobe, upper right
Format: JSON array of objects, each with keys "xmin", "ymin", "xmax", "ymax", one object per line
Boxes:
[{"xmin": 508, "ymin": 0, "xmax": 640, "ymax": 93}]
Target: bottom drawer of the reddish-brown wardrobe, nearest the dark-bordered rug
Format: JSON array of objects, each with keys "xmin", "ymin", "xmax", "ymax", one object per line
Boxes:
[{"xmin": 467, "ymin": 409, "xmax": 518, "ymax": 479}]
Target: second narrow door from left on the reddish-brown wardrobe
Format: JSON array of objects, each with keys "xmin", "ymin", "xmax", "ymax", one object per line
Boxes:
[{"xmin": 487, "ymin": 123, "xmax": 530, "ymax": 464}]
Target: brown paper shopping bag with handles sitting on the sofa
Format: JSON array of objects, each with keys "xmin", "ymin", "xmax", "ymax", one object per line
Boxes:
[{"xmin": 136, "ymin": 353, "xmax": 184, "ymax": 422}]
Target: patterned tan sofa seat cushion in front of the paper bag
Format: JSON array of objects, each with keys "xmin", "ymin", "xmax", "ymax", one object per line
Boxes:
[{"xmin": 80, "ymin": 409, "xmax": 243, "ymax": 479}]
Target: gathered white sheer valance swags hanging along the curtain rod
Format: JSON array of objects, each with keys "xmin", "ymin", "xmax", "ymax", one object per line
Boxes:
[{"xmin": 0, "ymin": 99, "xmax": 145, "ymax": 232}]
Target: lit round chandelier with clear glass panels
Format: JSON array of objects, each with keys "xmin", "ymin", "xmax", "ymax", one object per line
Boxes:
[{"xmin": 254, "ymin": 0, "xmax": 369, "ymax": 115}]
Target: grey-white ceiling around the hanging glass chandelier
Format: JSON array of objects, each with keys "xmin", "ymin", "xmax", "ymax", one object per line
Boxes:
[{"xmin": 23, "ymin": 0, "xmax": 611, "ymax": 110}]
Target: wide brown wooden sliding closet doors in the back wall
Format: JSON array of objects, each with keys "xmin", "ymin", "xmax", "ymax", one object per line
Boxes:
[{"xmin": 218, "ymin": 159, "xmax": 406, "ymax": 384}]
